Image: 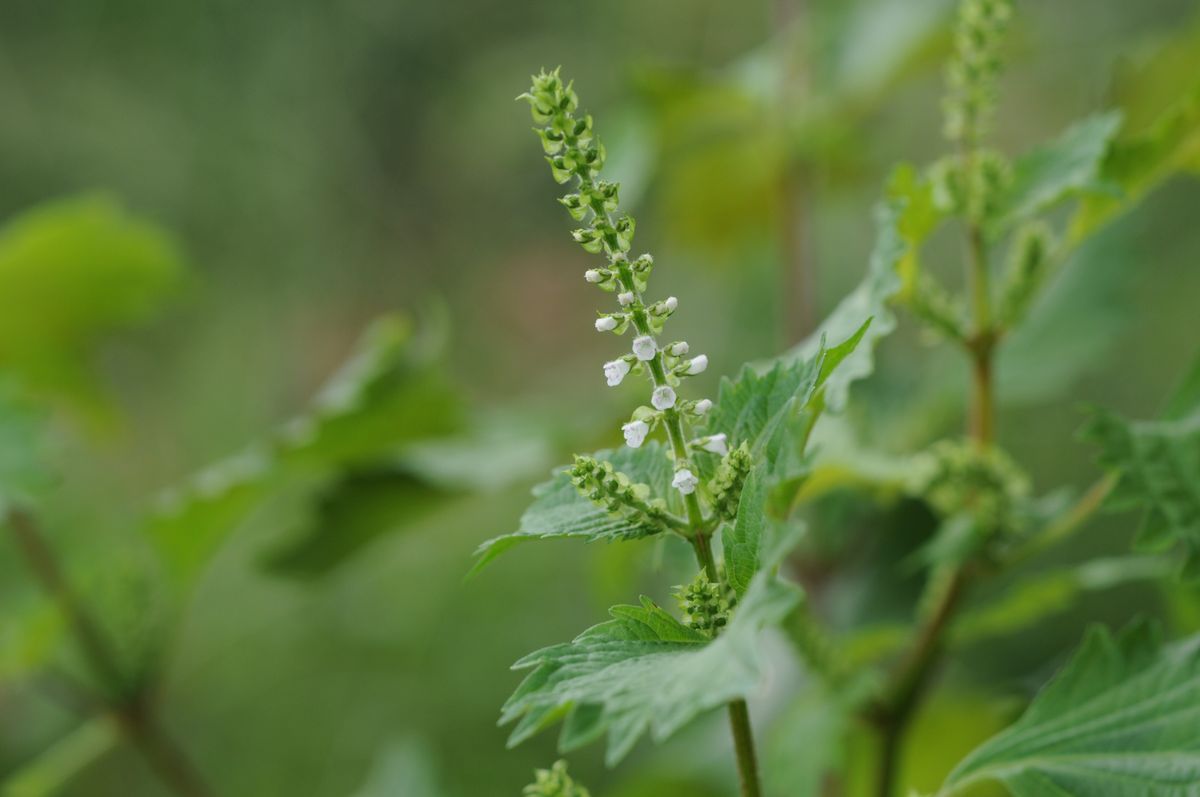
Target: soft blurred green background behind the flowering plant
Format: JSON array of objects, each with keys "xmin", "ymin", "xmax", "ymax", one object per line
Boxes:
[{"xmin": 0, "ymin": 0, "xmax": 1200, "ymax": 797}]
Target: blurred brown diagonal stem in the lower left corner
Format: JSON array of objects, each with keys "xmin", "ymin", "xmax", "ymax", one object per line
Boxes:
[{"xmin": 5, "ymin": 510, "xmax": 212, "ymax": 797}]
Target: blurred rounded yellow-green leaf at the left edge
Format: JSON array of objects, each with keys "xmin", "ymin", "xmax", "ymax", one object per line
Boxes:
[{"xmin": 0, "ymin": 196, "xmax": 184, "ymax": 403}]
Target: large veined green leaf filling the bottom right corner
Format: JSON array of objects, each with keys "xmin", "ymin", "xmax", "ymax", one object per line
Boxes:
[{"xmin": 940, "ymin": 623, "xmax": 1200, "ymax": 797}]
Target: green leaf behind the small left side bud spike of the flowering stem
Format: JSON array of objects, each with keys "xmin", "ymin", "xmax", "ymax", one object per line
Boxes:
[{"xmin": 472, "ymin": 441, "xmax": 674, "ymax": 574}]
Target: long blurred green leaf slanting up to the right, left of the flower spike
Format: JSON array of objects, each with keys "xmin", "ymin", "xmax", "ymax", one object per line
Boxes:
[{"xmin": 149, "ymin": 317, "xmax": 460, "ymax": 583}]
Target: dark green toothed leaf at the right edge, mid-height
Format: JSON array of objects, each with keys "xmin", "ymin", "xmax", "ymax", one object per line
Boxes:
[{"xmin": 1081, "ymin": 384, "xmax": 1200, "ymax": 577}]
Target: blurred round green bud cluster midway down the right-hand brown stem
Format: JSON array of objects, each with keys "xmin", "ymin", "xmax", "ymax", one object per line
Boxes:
[{"xmin": 912, "ymin": 441, "xmax": 1030, "ymax": 532}]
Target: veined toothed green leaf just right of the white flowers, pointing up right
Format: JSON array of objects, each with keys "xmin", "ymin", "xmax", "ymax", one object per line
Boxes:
[{"xmin": 706, "ymin": 317, "xmax": 871, "ymax": 474}]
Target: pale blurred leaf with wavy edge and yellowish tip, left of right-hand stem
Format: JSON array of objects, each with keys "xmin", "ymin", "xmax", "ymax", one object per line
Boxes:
[{"xmin": 782, "ymin": 166, "xmax": 940, "ymax": 412}]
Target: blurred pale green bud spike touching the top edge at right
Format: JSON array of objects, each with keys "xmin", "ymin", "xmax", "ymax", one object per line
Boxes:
[{"xmin": 943, "ymin": 0, "xmax": 1013, "ymax": 149}]
